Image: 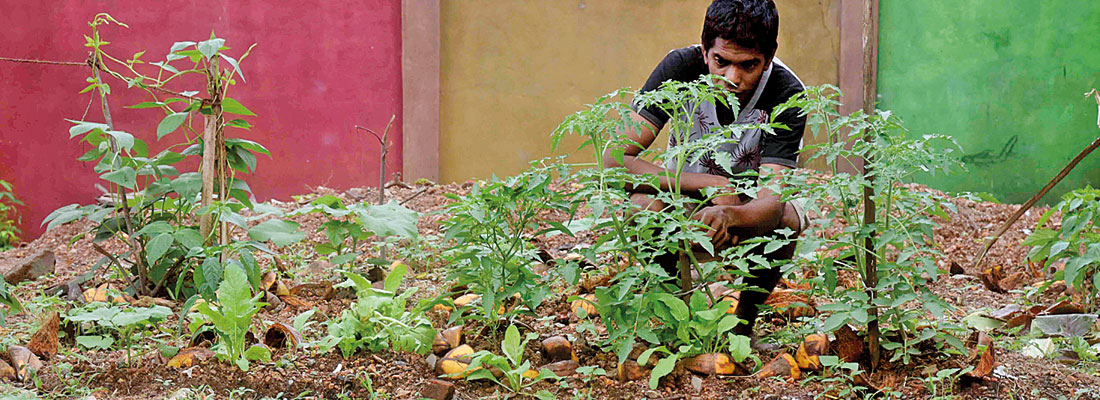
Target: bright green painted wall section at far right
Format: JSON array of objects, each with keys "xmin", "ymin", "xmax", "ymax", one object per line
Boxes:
[{"xmin": 878, "ymin": 0, "xmax": 1100, "ymax": 203}]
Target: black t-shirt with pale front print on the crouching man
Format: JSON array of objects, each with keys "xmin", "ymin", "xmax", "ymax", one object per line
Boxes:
[{"xmin": 635, "ymin": 45, "xmax": 806, "ymax": 169}]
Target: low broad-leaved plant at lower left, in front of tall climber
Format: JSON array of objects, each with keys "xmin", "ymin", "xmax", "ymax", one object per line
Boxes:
[{"xmin": 65, "ymin": 302, "xmax": 172, "ymax": 363}]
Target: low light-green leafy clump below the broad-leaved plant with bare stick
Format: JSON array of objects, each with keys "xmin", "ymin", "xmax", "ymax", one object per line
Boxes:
[{"xmin": 320, "ymin": 264, "xmax": 436, "ymax": 357}]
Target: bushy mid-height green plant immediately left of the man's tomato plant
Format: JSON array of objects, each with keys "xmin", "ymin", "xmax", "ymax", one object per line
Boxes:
[{"xmin": 444, "ymin": 162, "xmax": 572, "ymax": 333}]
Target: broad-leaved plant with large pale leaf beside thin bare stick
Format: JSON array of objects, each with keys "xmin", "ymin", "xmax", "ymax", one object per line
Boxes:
[{"xmin": 290, "ymin": 196, "xmax": 418, "ymax": 266}]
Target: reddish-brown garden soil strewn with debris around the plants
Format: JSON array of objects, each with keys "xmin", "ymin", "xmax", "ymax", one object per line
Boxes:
[{"xmin": 0, "ymin": 182, "xmax": 1100, "ymax": 399}]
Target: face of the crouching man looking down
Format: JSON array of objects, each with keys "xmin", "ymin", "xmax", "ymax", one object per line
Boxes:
[{"xmin": 703, "ymin": 37, "xmax": 771, "ymax": 103}]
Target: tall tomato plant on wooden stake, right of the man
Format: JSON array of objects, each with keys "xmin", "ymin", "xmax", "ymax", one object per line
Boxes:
[{"xmin": 783, "ymin": 86, "xmax": 963, "ymax": 363}]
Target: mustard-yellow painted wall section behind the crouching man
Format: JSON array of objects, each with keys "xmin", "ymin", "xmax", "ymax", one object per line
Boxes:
[{"xmin": 439, "ymin": 0, "xmax": 840, "ymax": 182}]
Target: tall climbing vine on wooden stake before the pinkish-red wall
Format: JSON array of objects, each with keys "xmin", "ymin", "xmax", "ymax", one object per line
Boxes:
[{"xmin": 43, "ymin": 13, "xmax": 305, "ymax": 299}]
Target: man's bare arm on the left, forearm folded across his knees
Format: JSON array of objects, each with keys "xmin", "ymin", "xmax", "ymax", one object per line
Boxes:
[{"xmin": 603, "ymin": 111, "xmax": 729, "ymax": 193}]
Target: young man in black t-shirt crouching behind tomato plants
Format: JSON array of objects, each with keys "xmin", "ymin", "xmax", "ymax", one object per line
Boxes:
[{"xmin": 604, "ymin": 0, "xmax": 806, "ymax": 343}]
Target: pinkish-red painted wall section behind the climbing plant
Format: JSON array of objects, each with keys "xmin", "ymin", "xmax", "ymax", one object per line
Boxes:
[{"xmin": 0, "ymin": 0, "xmax": 402, "ymax": 240}]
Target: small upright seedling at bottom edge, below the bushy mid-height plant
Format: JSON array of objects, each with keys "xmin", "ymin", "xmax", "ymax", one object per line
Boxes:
[{"xmin": 466, "ymin": 325, "xmax": 559, "ymax": 399}]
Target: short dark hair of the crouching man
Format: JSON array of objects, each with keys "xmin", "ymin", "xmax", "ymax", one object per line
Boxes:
[{"xmin": 703, "ymin": 0, "xmax": 779, "ymax": 59}]
